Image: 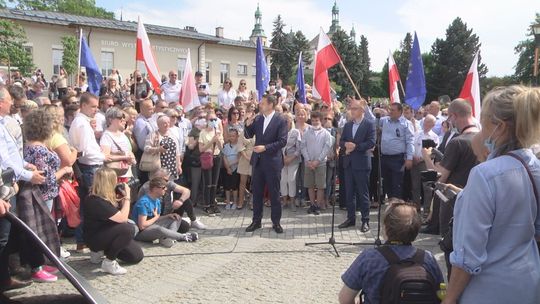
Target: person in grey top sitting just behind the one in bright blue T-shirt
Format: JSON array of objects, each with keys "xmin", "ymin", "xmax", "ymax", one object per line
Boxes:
[{"xmin": 137, "ymin": 169, "xmax": 206, "ymax": 229}]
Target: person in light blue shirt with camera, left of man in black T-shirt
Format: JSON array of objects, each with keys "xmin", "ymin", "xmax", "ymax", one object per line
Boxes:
[{"xmin": 411, "ymin": 114, "xmax": 439, "ymax": 210}]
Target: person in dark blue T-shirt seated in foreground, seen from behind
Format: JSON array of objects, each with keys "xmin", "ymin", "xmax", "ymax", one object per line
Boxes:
[{"xmin": 339, "ymin": 199, "xmax": 444, "ymax": 304}]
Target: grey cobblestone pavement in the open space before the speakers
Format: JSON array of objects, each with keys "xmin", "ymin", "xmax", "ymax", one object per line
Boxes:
[{"xmin": 8, "ymin": 208, "xmax": 445, "ymax": 304}]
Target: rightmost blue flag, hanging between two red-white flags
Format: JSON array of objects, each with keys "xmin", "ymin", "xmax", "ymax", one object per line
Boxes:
[{"xmin": 405, "ymin": 32, "xmax": 426, "ymax": 110}]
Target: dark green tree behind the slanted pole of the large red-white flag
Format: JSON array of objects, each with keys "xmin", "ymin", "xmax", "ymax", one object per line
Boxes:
[{"xmin": 328, "ymin": 30, "xmax": 363, "ymax": 99}]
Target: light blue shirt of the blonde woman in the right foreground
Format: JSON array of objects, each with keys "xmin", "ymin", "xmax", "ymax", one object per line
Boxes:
[{"xmin": 450, "ymin": 149, "xmax": 540, "ymax": 303}]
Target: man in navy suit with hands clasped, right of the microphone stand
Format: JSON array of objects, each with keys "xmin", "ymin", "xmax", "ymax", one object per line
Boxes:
[{"xmin": 338, "ymin": 100, "xmax": 375, "ymax": 232}]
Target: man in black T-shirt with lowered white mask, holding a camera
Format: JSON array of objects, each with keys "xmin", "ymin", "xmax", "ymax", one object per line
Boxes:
[{"xmin": 421, "ymin": 98, "xmax": 479, "ymax": 235}]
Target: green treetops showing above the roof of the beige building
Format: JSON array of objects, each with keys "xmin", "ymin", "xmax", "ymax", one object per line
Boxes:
[{"xmin": 9, "ymin": 0, "xmax": 114, "ymax": 19}]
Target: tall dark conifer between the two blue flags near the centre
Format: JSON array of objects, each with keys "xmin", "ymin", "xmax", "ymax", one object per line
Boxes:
[{"xmin": 270, "ymin": 15, "xmax": 298, "ymax": 82}]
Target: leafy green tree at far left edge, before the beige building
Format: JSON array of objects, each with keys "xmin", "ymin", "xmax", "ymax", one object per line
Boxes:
[{"xmin": 0, "ymin": 20, "xmax": 34, "ymax": 76}]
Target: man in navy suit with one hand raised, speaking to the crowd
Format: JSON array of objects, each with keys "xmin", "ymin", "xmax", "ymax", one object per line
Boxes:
[{"xmin": 244, "ymin": 95, "xmax": 288, "ymax": 233}]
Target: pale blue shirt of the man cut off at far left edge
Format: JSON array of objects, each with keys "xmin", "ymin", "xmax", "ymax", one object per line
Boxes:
[{"xmin": 0, "ymin": 117, "xmax": 32, "ymax": 181}]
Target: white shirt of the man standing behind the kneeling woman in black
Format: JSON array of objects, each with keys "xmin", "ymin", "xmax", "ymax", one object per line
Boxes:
[{"xmin": 69, "ymin": 113, "xmax": 105, "ymax": 166}]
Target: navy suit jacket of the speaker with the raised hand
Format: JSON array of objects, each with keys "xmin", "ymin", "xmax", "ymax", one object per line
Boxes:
[{"xmin": 244, "ymin": 112, "xmax": 288, "ymax": 171}]
